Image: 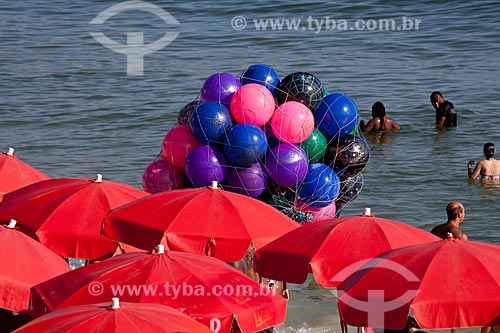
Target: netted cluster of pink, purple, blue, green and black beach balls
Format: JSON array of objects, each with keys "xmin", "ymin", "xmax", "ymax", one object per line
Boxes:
[{"xmin": 143, "ymin": 64, "xmax": 369, "ymax": 222}]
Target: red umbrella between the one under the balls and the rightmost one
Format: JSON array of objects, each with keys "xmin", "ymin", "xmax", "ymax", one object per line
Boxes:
[{"xmin": 255, "ymin": 208, "xmax": 439, "ymax": 288}]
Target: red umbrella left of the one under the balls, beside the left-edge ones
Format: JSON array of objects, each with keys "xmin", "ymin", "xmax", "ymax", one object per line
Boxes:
[{"xmin": 0, "ymin": 174, "xmax": 149, "ymax": 260}]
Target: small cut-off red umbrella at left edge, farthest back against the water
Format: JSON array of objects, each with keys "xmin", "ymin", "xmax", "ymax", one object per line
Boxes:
[{"xmin": 0, "ymin": 148, "xmax": 50, "ymax": 202}]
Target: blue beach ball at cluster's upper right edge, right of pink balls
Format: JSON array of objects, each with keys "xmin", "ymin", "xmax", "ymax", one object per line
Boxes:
[{"xmin": 314, "ymin": 93, "xmax": 359, "ymax": 137}]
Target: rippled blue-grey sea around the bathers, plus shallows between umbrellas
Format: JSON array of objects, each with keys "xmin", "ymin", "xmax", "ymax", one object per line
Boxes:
[{"xmin": 0, "ymin": 0, "xmax": 500, "ymax": 332}]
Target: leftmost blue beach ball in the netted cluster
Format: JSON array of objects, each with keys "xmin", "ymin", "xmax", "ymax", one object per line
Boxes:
[{"xmin": 189, "ymin": 102, "xmax": 232, "ymax": 144}]
